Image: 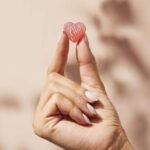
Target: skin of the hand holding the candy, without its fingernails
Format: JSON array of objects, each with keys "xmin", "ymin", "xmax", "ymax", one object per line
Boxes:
[{"xmin": 33, "ymin": 33, "xmax": 133, "ymax": 150}]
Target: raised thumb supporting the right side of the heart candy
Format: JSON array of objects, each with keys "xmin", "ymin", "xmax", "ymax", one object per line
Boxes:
[{"xmin": 76, "ymin": 35, "xmax": 105, "ymax": 92}]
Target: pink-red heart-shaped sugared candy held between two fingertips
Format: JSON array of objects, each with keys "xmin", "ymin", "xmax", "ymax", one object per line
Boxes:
[{"xmin": 64, "ymin": 22, "xmax": 86, "ymax": 43}]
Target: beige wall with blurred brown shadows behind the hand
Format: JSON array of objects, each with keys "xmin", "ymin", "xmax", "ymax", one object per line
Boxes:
[{"xmin": 0, "ymin": 0, "xmax": 150, "ymax": 150}]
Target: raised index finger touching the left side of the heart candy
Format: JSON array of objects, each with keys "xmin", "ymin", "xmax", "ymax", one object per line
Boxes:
[{"xmin": 48, "ymin": 33, "xmax": 69, "ymax": 75}]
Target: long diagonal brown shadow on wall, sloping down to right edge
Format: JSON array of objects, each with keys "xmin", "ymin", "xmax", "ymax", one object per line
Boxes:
[{"xmin": 100, "ymin": 35, "xmax": 150, "ymax": 79}]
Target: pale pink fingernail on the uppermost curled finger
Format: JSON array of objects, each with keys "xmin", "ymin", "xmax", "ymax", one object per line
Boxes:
[{"xmin": 85, "ymin": 91, "xmax": 99, "ymax": 103}]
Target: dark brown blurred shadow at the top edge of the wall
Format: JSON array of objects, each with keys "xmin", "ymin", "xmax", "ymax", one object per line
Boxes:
[{"xmin": 101, "ymin": 0, "xmax": 134, "ymax": 24}]
